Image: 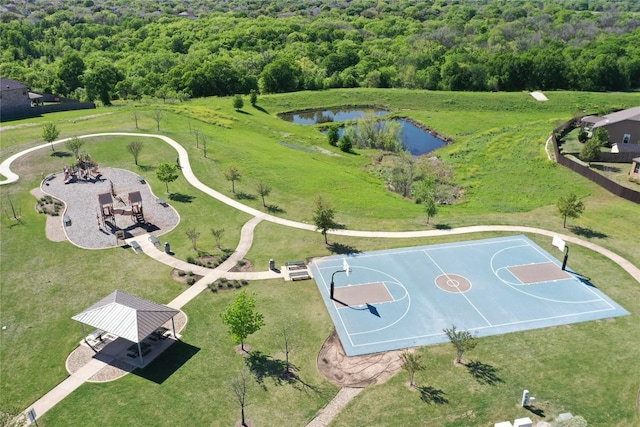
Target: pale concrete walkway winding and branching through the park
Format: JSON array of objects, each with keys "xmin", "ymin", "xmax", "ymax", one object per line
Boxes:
[{"xmin": 0, "ymin": 132, "xmax": 640, "ymax": 427}]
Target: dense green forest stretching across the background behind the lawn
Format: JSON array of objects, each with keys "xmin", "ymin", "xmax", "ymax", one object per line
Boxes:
[{"xmin": 0, "ymin": 0, "xmax": 640, "ymax": 104}]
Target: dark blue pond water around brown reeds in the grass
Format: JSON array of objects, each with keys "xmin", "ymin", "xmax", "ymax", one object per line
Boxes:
[{"xmin": 279, "ymin": 107, "xmax": 446, "ymax": 156}]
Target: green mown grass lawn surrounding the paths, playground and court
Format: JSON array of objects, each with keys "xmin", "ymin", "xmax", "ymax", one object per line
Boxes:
[{"xmin": 0, "ymin": 90, "xmax": 640, "ymax": 426}]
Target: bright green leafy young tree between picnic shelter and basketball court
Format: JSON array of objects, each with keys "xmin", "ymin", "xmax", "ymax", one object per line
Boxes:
[{"xmin": 220, "ymin": 290, "xmax": 264, "ymax": 351}]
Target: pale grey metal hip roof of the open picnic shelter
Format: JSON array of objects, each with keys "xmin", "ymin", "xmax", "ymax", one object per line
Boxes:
[{"xmin": 72, "ymin": 291, "xmax": 179, "ymax": 342}]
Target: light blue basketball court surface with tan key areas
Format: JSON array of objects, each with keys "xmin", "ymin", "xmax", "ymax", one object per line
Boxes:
[{"xmin": 310, "ymin": 236, "xmax": 629, "ymax": 356}]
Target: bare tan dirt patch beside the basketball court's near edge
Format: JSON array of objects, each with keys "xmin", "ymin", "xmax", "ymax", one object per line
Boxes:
[{"xmin": 317, "ymin": 331, "xmax": 402, "ymax": 387}]
